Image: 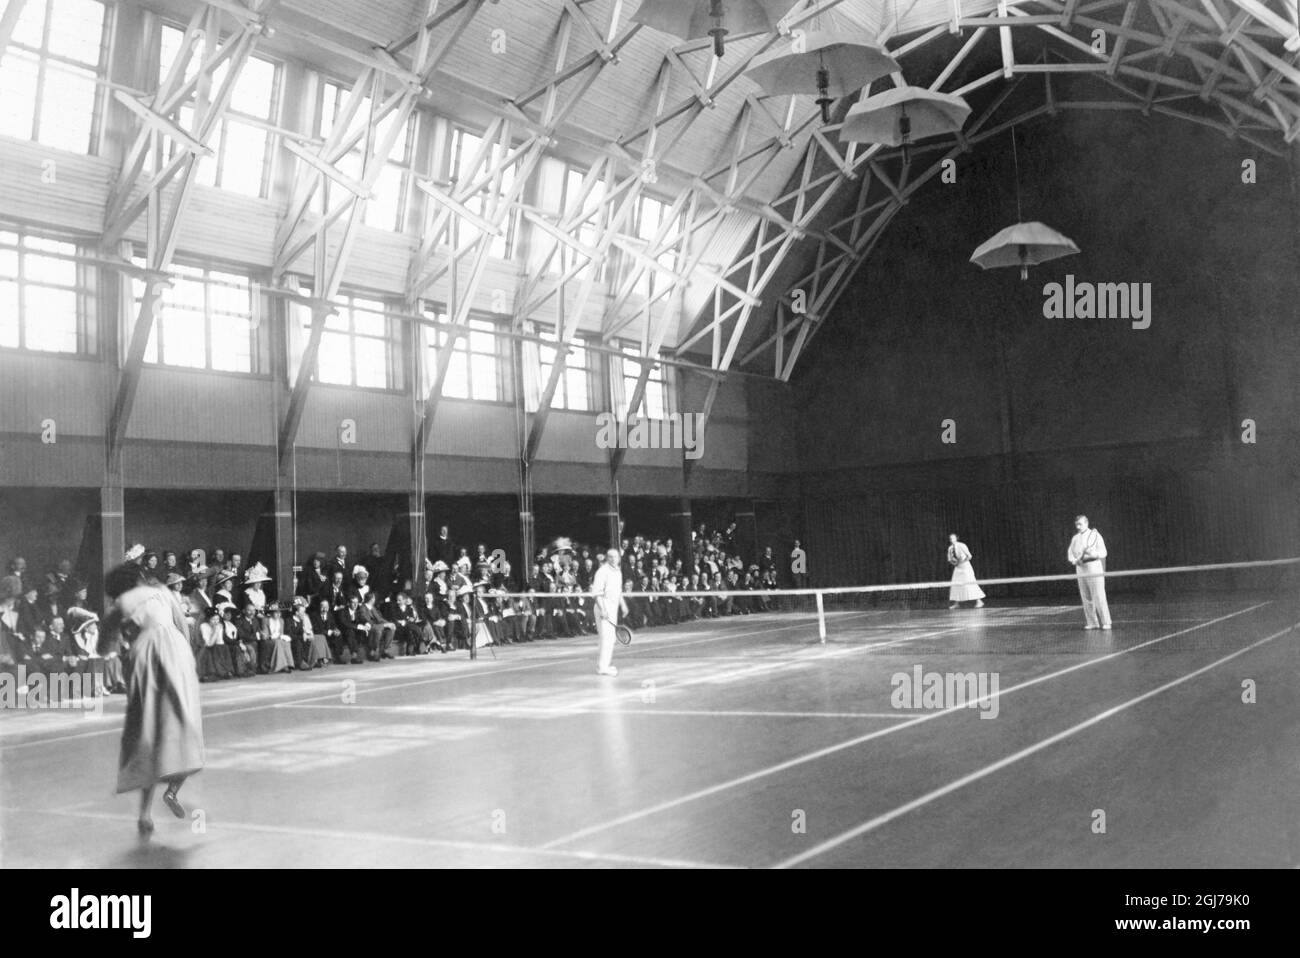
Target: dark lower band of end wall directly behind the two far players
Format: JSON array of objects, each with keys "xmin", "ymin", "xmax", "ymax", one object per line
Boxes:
[{"xmin": 805, "ymin": 462, "xmax": 1300, "ymax": 588}]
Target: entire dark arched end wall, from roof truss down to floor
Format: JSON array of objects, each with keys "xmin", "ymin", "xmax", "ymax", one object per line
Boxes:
[{"xmin": 793, "ymin": 105, "xmax": 1300, "ymax": 582}]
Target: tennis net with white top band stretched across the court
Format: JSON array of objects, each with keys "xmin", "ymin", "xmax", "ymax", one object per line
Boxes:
[{"xmin": 471, "ymin": 558, "xmax": 1300, "ymax": 653}]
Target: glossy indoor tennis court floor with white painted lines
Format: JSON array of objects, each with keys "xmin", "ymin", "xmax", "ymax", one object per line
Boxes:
[{"xmin": 0, "ymin": 566, "xmax": 1300, "ymax": 868}]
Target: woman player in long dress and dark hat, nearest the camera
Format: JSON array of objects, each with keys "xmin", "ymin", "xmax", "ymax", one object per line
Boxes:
[{"xmin": 103, "ymin": 567, "xmax": 204, "ymax": 837}]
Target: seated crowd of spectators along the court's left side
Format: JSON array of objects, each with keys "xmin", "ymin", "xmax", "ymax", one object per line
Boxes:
[{"xmin": 0, "ymin": 523, "xmax": 803, "ymax": 694}]
